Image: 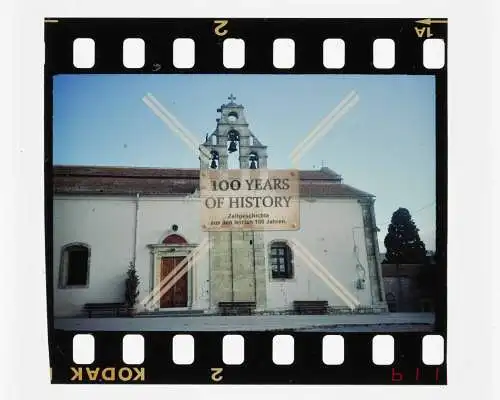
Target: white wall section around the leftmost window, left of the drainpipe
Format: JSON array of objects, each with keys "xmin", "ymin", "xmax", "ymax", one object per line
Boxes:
[{"xmin": 53, "ymin": 196, "xmax": 134, "ymax": 316}]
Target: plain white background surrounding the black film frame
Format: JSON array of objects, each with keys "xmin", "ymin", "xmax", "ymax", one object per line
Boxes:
[{"xmin": 0, "ymin": 0, "xmax": 500, "ymax": 400}]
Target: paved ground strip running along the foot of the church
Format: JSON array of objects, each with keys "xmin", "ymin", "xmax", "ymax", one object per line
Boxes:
[{"xmin": 55, "ymin": 313, "xmax": 434, "ymax": 332}]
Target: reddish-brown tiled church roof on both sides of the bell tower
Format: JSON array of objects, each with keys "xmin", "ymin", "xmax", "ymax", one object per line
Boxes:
[{"xmin": 53, "ymin": 166, "xmax": 372, "ymax": 198}]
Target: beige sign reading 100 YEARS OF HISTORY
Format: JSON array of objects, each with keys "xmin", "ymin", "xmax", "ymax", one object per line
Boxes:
[{"xmin": 200, "ymin": 169, "xmax": 300, "ymax": 232}]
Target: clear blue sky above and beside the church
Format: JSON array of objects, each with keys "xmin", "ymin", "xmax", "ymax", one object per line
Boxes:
[{"xmin": 53, "ymin": 74, "xmax": 436, "ymax": 252}]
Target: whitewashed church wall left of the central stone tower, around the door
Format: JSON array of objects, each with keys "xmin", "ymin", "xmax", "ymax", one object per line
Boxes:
[{"xmin": 53, "ymin": 196, "xmax": 208, "ymax": 316}]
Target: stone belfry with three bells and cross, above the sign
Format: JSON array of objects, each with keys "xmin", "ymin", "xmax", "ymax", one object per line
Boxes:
[{"xmin": 200, "ymin": 93, "xmax": 267, "ymax": 169}]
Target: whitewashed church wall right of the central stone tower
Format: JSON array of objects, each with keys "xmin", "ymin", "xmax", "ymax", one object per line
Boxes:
[{"xmin": 265, "ymin": 199, "xmax": 371, "ymax": 309}]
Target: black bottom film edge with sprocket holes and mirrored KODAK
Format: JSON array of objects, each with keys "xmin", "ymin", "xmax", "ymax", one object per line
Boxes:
[{"xmin": 51, "ymin": 332, "xmax": 446, "ymax": 385}]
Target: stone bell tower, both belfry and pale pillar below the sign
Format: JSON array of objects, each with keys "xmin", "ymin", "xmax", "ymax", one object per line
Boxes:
[{"xmin": 200, "ymin": 94, "xmax": 267, "ymax": 310}]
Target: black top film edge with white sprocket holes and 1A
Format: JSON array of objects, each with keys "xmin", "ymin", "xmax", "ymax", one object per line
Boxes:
[{"xmin": 46, "ymin": 18, "xmax": 446, "ymax": 76}]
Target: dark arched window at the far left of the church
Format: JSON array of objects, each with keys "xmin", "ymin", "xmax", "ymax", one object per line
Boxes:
[{"xmin": 59, "ymin": 243, "xmax": 90, "ymax": 288}]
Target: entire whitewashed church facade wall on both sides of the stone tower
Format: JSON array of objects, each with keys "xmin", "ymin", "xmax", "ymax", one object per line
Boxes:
[{"xmin": 53, "ymin": 196, "xmax": 371, "ymax": 316}]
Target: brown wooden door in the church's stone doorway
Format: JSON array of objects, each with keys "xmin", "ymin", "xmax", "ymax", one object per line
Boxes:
[{"xmin": 160, "ymin": 257, "xmax": 188, "ymax": 308}]
